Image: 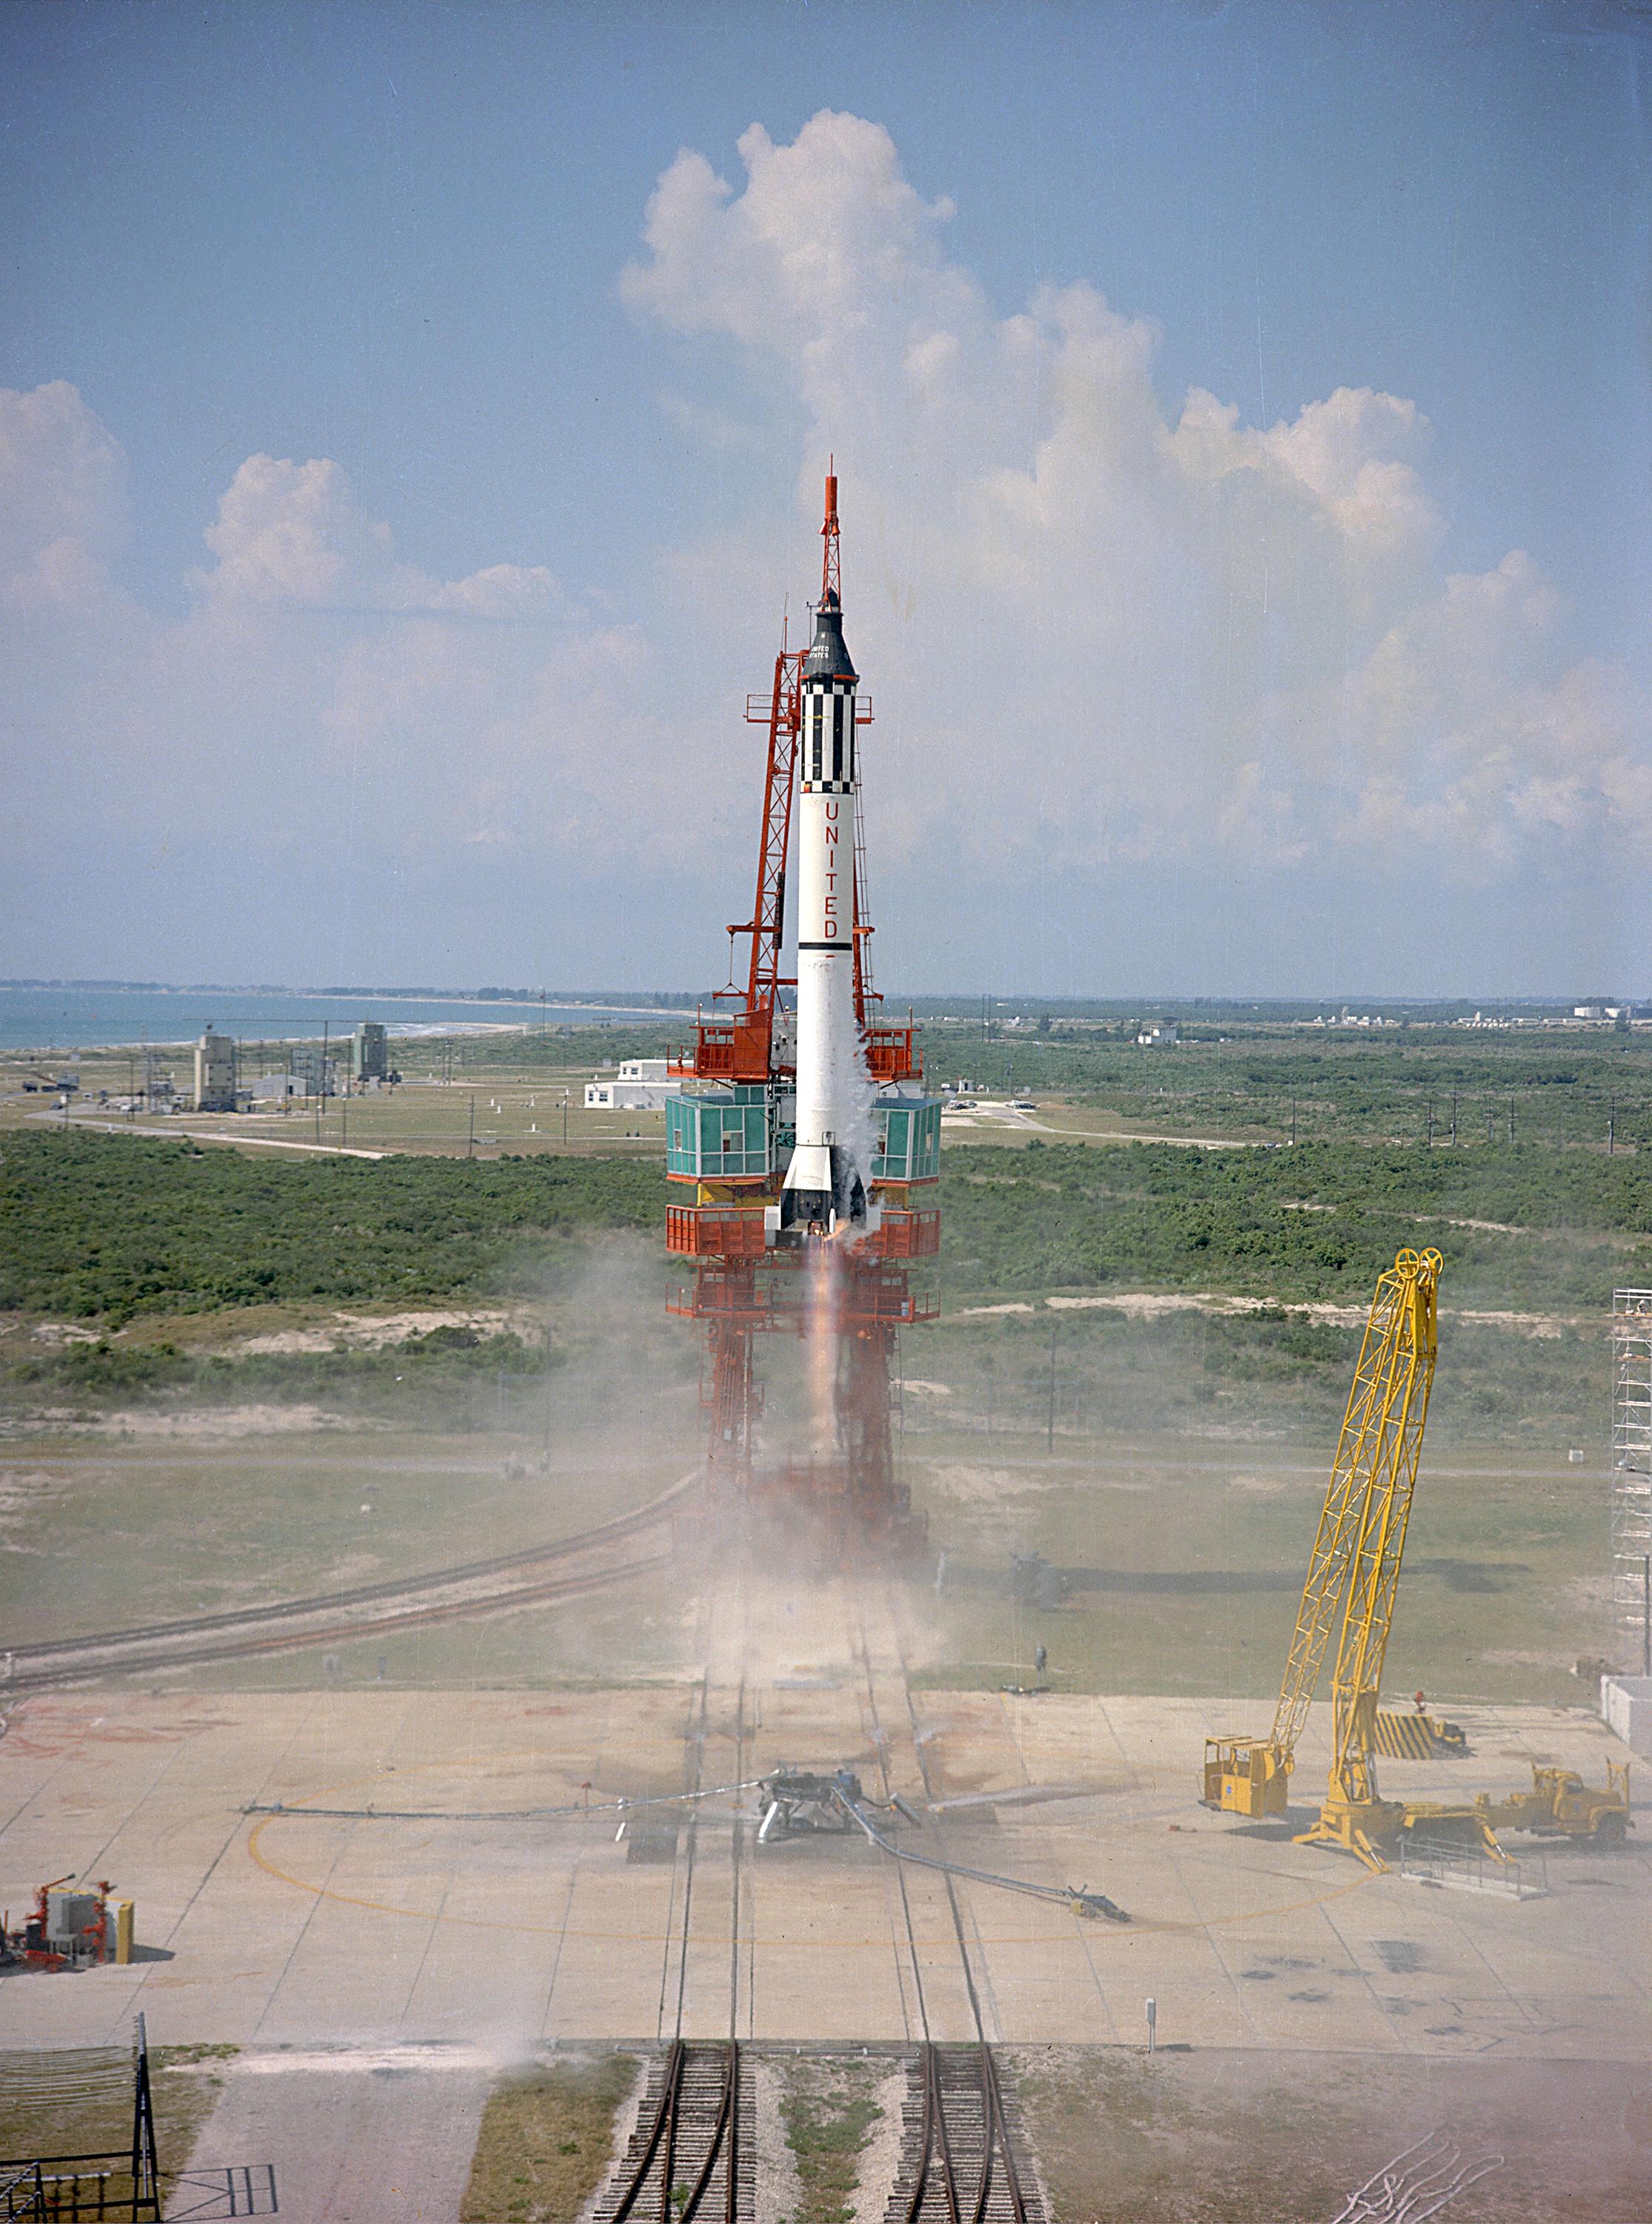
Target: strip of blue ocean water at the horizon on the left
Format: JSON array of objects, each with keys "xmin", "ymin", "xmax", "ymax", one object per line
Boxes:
[{"xmin": 0, "ymin": 985, "xmax": 687, "ymax": 1052}]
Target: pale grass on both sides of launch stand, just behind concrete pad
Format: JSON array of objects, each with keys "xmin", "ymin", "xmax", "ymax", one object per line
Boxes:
[{"xmin": 0, "ymin": 1430, "xmax": 1603, "ymax": 1704}]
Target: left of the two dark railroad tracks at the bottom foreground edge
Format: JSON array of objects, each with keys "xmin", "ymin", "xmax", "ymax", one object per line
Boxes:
[{"xmin": 594, "ymin": 2039, "xmax": 754, "ymax": 2224}]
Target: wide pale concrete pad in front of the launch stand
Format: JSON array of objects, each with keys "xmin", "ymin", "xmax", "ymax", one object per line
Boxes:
[{"xmin": 0, "ymin": 1648, "xmax": 1652, "ymax": 2059}]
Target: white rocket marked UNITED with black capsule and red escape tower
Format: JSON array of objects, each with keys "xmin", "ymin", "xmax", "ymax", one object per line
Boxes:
[{"xmin": 780, "ymin": 476, "xmax": 872, "ymax": 1239}]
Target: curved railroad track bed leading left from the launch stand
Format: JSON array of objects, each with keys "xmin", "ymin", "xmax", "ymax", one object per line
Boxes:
[{"xmin": 0, "ymin": 1477, "xmax": 698, "ymax": 1699}]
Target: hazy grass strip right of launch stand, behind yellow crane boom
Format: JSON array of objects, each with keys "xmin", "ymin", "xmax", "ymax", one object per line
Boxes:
[{"xmin": 907, "ymin": 1437, "xmax": 1603, "ymax": 1706}]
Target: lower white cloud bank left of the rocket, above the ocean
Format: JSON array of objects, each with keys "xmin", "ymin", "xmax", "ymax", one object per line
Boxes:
[{"xmin": 0, "ymin": 385, "xmax": 694, "ymax": 903}]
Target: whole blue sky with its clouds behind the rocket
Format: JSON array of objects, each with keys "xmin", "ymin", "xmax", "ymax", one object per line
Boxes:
[{"xmin": 0, "ymin": 0, "xmax": 1652, "ymax": 994}]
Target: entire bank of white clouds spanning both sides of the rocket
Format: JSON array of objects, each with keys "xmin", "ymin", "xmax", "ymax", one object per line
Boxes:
[{"xmin": 0, "ymin": 111, "xmax": 1652, "ymax": 992}]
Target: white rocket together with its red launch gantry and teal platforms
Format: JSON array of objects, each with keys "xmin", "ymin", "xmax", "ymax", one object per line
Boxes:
[{"xmin": 665, "ymin": 476, "xmax": 941, "ymax": 1543}]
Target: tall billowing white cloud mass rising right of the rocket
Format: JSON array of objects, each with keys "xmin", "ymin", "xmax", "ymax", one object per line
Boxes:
[{"xmin": 623, "ymin": 111, "xmax": 1652, "ymax": 878}]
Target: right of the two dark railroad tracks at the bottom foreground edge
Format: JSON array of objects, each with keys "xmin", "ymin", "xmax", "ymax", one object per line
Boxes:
[{"xmin": 885, "ymin": 2039, "xmax": 1045, "ymax": 2224}]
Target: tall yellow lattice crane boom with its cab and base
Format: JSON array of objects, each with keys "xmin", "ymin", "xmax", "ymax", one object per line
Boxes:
[{"xmin": 1203, "ymin": 1250, "xmax": 1459, "ymax": 1866}]
